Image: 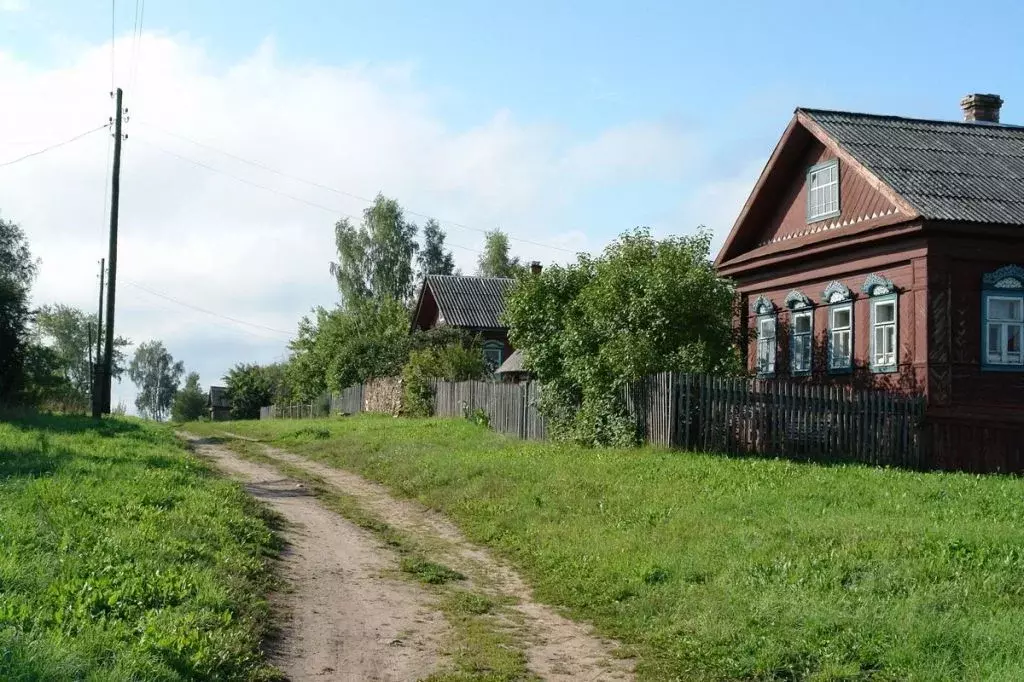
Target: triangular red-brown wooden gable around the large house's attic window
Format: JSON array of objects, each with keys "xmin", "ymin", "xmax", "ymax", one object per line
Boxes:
[{"xmin": 716, "ymin": 110, "xmax": 916, "ymax": 273}]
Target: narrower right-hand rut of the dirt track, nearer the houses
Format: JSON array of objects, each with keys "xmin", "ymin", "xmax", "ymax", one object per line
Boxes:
[{"xmin": 225, "ymin": 433, "xmax": 633, "ymax": 681}]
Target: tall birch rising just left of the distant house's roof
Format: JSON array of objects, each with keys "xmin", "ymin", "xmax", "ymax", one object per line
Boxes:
[{"xmin": 331, "ymin": 195, "xmax": 418, "ymax": 306}]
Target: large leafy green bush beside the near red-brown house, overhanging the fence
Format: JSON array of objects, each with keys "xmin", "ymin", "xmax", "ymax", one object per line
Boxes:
[{"xmin": 505, "ymin": 229, "xmax": 740, "ymax": 444}]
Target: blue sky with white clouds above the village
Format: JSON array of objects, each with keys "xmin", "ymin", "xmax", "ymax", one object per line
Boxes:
[{"xmin": 0, "ymin": 0, "xmax": 1024, "ymax": 407}]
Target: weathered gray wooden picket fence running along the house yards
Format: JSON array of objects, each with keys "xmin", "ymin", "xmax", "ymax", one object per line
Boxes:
[{"xmin": 260, "ymin": 373, "xmax": 933, "ymax": 469}]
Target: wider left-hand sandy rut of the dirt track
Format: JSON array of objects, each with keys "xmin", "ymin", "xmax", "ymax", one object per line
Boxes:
[{"xmin": 185, "ymin": 436, "xmax": 447, "ymax": 682}]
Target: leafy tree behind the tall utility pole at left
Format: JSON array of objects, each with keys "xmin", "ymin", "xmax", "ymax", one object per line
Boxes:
[{"xmin": 34, "ymin": 303, "xmax": 130, "ymax": 404}]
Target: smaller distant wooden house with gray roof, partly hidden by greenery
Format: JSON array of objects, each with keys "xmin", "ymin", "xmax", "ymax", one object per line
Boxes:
[{"xmin": 413, "ymin": 274, "xmax": 515, "ymax": 369}]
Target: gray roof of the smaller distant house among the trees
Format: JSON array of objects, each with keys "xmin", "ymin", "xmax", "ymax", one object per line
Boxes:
[{"xmin": 427, "ymin": 274, "xmax": 515, "ymax": 329}]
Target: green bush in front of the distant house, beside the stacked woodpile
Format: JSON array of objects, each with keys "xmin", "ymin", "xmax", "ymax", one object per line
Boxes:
[{"xmin": 401, "ymin": 337, "xmax": 487, "ymax": 417}]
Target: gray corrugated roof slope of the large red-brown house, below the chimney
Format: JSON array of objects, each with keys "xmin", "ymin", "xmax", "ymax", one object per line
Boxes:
[{"xmin": 798, "ymin": 109, "xmax": 1024, "ymax": 225}]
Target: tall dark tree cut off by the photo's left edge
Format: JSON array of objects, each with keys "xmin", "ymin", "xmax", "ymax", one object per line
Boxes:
[{"xmin": 0, "ymin": 218, "xmax": 38, "ymax": 404}]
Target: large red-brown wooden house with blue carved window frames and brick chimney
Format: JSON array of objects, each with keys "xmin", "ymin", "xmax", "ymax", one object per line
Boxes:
[{"xmin": 716, "ymin": 94, "xmax": 1024, "ymax": 470}]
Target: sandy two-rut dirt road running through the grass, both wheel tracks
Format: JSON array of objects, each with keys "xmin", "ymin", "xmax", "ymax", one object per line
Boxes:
[{"xmin": 188, "ymin": 434, "xmax": 633, "ymax": 681}]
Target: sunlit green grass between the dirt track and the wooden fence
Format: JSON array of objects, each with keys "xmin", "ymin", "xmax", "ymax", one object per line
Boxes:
[{"xmin": 197, "ymin": 416, "xmax": 1024, "ymax": 680}]
